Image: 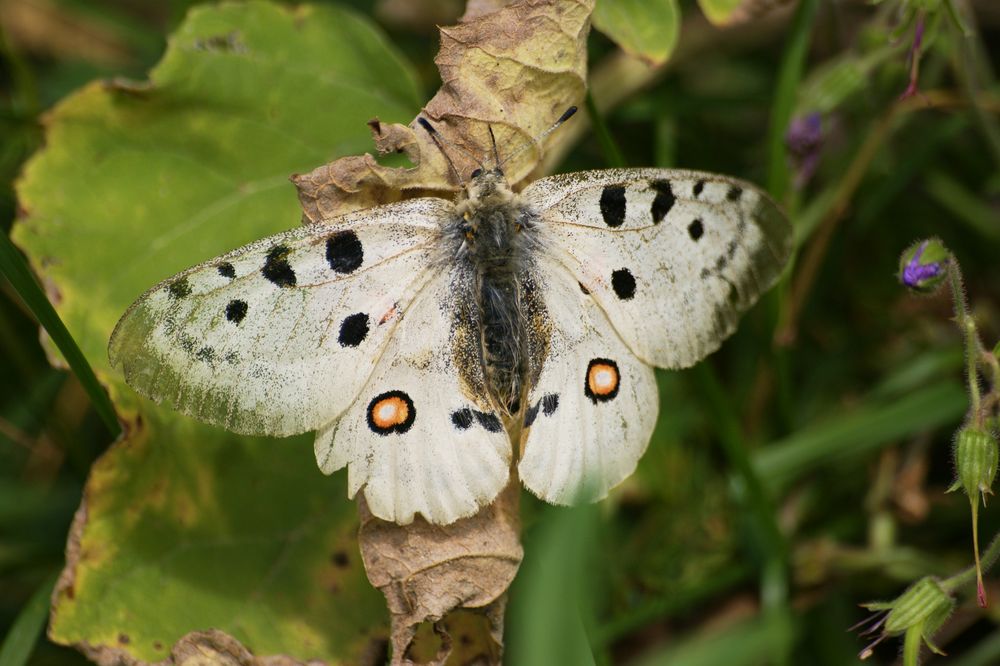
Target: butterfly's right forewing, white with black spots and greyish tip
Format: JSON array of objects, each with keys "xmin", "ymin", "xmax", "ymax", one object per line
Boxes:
[{"xmin": 523, "ymin": 169, "xmax": 792, "ymax": 368}]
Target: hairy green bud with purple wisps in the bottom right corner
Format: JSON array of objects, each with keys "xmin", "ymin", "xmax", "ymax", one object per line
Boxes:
[{"xmin": 860, "ymin": 576, "xmax": 955, "ymax": 659}]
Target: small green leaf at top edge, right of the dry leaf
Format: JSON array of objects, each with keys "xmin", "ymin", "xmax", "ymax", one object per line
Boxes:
[{"xmin": 593, "ymin": 0, "xmax": 681, "ymax": 65}]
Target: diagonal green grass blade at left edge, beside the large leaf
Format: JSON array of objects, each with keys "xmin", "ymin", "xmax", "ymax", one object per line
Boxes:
[{"xmin": 0, "ymin": 234, "xmax": 121, "ymax": 437}]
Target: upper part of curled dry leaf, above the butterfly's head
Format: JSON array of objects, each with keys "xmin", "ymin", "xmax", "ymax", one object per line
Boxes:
[{"xmin": 292, "ymin": 0, "xmax": 594, "ymax": 222}]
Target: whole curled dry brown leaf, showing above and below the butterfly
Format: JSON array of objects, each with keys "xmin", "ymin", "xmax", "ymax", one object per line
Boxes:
[{"xmin": 326, "ymin": 0, "xmax": 594, "ymax": 664}]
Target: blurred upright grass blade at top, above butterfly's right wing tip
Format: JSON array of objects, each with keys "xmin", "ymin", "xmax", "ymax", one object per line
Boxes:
[{"xmin": 767, "ymin": 0, "xmax": 819, "ymax": 201}]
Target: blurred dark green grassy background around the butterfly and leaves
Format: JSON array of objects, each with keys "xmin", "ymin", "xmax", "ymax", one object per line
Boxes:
[{"xmin": 0, "ymin": 0, "xmax": 1000, "ymax": 666}]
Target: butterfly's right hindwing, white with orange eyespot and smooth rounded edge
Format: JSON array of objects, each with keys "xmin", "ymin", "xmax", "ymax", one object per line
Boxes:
[{"xmin": 518, "ymin": 260, "xmax": 658, "ymax": 504}]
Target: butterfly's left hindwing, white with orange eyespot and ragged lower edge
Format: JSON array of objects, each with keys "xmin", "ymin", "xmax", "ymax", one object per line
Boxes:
[{"xmin": 316, "ymin": 267, "xmax": 512, "ymax": 524}]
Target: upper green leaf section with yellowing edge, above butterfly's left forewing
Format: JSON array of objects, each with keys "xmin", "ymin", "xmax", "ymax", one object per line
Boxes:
[{"xmin": 13, "ymin": 2, "xmax": 420, "ymax": 398}]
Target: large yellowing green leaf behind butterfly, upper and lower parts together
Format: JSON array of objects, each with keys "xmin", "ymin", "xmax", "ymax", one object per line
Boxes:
[{"xmin": 13, "ymin": 2, "xmax": 421, "ymax": 664}]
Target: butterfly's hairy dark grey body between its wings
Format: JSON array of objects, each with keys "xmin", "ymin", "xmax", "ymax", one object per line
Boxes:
[{"xmin": 446, "ymin": 170, "xmax": 539, "ymax": 414}]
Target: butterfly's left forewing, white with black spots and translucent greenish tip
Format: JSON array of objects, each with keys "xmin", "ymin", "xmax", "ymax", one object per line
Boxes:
[{"xmin": 109, "ymin": 198, "xmax": 453, "ymax": 436}]
